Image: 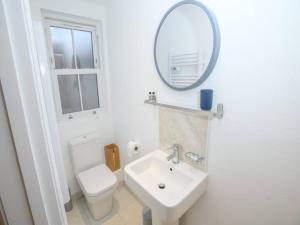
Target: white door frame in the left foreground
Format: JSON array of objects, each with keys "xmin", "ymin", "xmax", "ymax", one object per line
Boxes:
[{"xmin": 0, "ymin": 0, "xmax": 67, "ymax": 225}]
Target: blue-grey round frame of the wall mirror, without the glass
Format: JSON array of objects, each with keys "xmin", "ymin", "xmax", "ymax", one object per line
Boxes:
[{"xmin": 154, "ymin": 0, "xmax": 221, "ymax": 91}]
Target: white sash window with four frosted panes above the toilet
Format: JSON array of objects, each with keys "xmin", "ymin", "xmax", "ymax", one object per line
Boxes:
[{"xmin": 46, "ymin": 19, "xmax": 101, "ymax": 119}]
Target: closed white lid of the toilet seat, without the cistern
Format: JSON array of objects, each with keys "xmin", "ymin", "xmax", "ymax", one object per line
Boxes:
[{"xmin": 78, "ymin": 164, "xmax": 117, "ymax": 196}]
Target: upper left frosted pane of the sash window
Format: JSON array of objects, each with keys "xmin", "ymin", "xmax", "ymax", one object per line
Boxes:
[{"xmin": 50, "ymin": 27, "xmax": 75, "ymax": 69}]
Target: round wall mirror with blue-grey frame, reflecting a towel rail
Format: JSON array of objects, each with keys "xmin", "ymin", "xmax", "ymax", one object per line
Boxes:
[{"xmin": 154, "ymin": 0, "xmax": 220, "ymax": 90}]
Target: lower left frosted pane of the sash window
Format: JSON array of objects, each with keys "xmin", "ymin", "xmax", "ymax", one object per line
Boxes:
[{"xmin": 58, "ymin": 75, "xmax": 81, "ymax": 114}]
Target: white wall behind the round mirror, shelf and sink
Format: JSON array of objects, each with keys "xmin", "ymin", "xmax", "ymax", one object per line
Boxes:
[{"xmin": 107, "ymin": 0, "xmax": 300, "ymax": 225}]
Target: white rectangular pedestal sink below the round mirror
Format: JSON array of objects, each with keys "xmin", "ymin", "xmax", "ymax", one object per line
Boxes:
[{"xmin": 125, "ymin": 150, "xmax": 207, "ymax": 225}]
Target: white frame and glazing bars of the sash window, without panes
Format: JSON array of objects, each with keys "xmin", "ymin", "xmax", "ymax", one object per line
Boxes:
[{"xmin": 44, "ymin": 13, "xmax": 104, "ymax": 120}]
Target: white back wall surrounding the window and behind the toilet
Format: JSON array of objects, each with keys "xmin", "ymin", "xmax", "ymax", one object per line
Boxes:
[{"xmin": 31, "ymin": 0, "xmax": 114, "ymax": 194}]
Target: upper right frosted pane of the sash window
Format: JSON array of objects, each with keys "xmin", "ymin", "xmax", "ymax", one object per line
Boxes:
[{"xmin": 73, "ymin": 30, "xmax": 94, "ymax": 69}]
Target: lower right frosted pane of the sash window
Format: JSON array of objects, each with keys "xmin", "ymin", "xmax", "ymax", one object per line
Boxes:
[{"xmin": 80, "ymin": 74, "xmax": 99, "ymax": 110}]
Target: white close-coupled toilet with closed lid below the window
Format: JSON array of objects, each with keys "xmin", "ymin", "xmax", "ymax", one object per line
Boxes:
[{"xmin": 69, "ymin": 133, "xmax": 117, "ymax": 220}]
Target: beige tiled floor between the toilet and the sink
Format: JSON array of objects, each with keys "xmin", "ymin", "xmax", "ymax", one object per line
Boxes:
[{"xmin": 67, "ymin": 185, "xmax": 143, "ymax": 225}]
